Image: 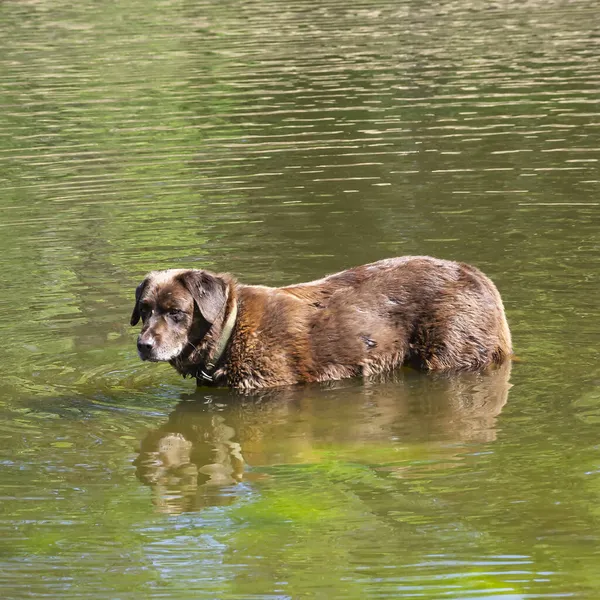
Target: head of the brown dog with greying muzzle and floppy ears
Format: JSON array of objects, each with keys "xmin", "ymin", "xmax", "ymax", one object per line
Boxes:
[{"xmin": 131, "ymin": 269, "xmax": 227, "ymax": 361}]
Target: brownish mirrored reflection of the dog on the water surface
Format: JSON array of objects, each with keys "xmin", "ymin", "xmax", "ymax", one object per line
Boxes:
[{"xmin": 135, "ymin": 364, "xmax": 510, "ymax": 513}]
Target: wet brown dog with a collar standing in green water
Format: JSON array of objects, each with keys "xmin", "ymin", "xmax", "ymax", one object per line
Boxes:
[{"xmin": 131, "ymin": 256, "xmax": 512, "ymax": 389}]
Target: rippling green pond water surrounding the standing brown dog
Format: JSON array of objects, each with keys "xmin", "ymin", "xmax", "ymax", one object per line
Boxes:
[{"xmin": 0, "ymin": 0, "xmax": 600, "ymax": 600}]
